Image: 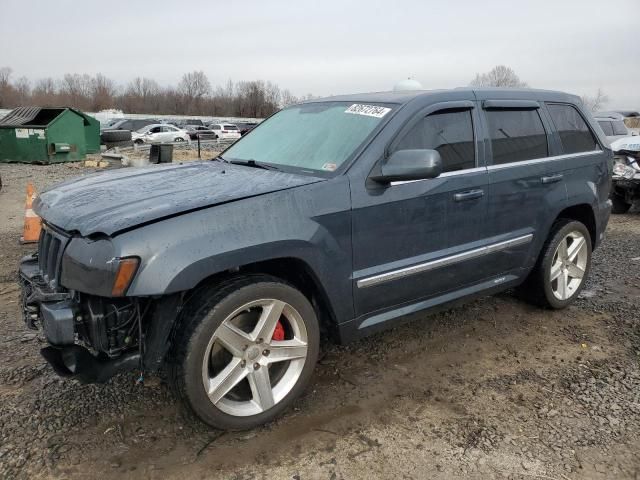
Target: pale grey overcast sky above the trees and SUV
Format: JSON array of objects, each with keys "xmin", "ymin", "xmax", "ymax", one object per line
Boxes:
[{"xmin": 0, "ymin": 0, "xmax": 640, "ymax": 109}]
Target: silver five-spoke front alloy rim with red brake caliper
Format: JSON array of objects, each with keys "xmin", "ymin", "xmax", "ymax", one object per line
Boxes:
[{"xmin": 202, "ymin": 299, "xmax": 308, "ymax": 417}]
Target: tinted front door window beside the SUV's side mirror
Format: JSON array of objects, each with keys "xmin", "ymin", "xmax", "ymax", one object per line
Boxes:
[{"xmin": 395, "ymin": 110, "xmax": 476, "ymax": 172}]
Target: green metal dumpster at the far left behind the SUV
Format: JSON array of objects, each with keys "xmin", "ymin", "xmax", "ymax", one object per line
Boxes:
[{"xmin": 0, "ymin": 107, "xmax": 100, "ymax": 163}]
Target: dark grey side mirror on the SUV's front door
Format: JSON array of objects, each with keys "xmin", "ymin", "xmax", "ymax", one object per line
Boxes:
[{"xmin": 371, "ymin": 150, "xmax": 442, "ymax": 183}]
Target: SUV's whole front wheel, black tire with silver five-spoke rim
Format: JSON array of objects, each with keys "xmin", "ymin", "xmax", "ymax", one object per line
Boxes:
[{"xmin": 169, "ymin": 275, "xmax": 320, "ymax": 430}]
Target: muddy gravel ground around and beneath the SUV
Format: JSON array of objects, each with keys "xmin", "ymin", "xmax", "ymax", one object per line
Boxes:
[{"xmin": 0, "ymin": 165, "xmax": 640, "ymax": 480}]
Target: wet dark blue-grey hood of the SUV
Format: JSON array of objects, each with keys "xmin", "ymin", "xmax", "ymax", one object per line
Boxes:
[{"xmin": 34, "ymin": 161, "xmax": 322, "ymax": 235}]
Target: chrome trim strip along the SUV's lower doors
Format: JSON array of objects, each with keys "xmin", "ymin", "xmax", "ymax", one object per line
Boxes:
[{"xmin": 357, "ymin": 233, "xmax": 533, "ymax": 288}]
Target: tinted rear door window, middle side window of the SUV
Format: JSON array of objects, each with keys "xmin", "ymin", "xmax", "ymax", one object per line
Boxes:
[{"xmin": 485, "ymin": 109, "xmax": 549, "ymax": 165}]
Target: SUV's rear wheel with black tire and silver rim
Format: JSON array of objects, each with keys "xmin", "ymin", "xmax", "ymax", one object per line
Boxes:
[{"xmin": 518, "ymin": 218, "xmax": 592, "ymax": 309}]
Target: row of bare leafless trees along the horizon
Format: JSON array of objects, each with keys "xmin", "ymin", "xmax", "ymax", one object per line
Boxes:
[{"xmin": 0, "ymin": 67, "xmax": 312, "ymax": 118}]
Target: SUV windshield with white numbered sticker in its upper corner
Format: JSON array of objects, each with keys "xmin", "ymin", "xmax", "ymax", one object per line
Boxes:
[{"xmin": 224, "ymin": 102, "xmax": 391, "ymax": 172}]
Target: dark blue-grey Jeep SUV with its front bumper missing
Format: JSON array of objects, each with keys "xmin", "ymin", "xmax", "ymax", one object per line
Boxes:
[{"xmin": 20, "ymin": 89, "xmax": 612, "ymax": 429}]
